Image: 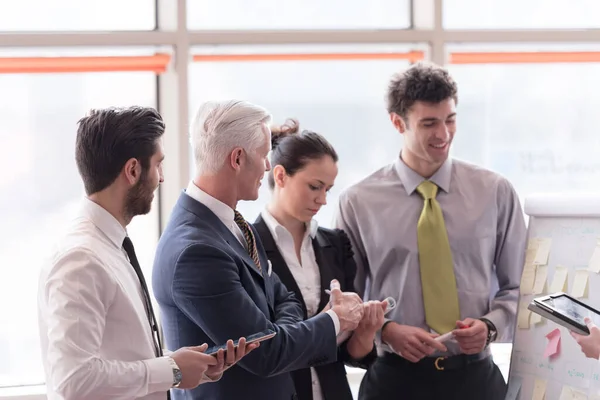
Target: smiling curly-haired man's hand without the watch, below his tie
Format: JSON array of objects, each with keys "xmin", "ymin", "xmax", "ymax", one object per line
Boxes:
[{"xmin": 381, "ymin": 322, "xmax": 446, "ymax": 363}]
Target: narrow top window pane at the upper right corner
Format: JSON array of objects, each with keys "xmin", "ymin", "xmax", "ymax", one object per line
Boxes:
[{"xmin": 443, "ymin": 0, "xmax": 600, "ymax": 29}]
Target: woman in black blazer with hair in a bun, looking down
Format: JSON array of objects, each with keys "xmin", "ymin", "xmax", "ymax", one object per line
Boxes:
[{"xmin": 254, "ymin": 119, "xmax": 385, "ymax": 400}]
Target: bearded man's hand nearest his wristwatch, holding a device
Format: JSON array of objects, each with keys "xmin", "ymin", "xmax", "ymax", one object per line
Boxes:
[{"xmin": 171, "ymin": 343, "xmax": 217, "ymax": 389}]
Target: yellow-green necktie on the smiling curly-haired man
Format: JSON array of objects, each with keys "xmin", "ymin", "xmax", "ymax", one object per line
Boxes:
[{"xmin": 417, "ymin": 181, "xmax": 460, "ymax": 334}]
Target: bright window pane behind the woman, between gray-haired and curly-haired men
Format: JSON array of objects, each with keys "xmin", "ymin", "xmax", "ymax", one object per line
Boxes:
[{"xmin": 190, "ymin": 46, "xmax": 422, "ymax": 226}]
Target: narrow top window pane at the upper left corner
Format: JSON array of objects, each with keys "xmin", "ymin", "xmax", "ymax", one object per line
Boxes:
[{"xmin": 0, "ymin": 0, "xmax": 156, "ymax": 31}]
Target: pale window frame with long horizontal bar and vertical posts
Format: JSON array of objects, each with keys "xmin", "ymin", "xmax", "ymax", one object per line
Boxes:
[{"xmin": 0, "ymin": 0, "xmax": 600, "ymax": 400}]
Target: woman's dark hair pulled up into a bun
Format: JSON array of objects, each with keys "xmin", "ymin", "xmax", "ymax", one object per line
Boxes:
[{"xmin": 268, "ymin": 118, "xmax": 338, "ymax": 189}]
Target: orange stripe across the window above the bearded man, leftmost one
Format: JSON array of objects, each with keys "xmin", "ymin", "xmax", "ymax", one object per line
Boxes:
[{"xmin": 0, "ymin": 54, "xmax": 171, "ymax": 74}]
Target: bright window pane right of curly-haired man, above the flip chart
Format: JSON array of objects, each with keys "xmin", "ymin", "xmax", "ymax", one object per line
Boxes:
[{"xmin": 450, "ymin": 46, "xmax": 600, "ymax": 197}]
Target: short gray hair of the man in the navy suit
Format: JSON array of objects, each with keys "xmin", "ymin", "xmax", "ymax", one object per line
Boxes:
[{"xmin": 190, "ymin": 100, "xmax": 271, "ymax": 175}]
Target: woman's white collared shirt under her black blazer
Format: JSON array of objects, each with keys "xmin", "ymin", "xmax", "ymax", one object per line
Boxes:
[{"xmin": 261, "ymin": 209, "xmax": 323, "ymax": 400}]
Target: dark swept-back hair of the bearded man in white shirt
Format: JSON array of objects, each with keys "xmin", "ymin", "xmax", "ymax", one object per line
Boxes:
[{"xmin": 75, "ymin": 106, "xmax": 165, "ymax": 195}]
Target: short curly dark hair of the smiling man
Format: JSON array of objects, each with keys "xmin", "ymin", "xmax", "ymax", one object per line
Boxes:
[{"xmin": 387, "ymin": 62, "xmax": 458, "ymax": 119}]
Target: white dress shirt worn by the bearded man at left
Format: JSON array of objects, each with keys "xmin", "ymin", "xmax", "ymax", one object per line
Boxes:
[{"xmin": 38, "ymin": 199, "xmax": 173, "ymax": 400}]
